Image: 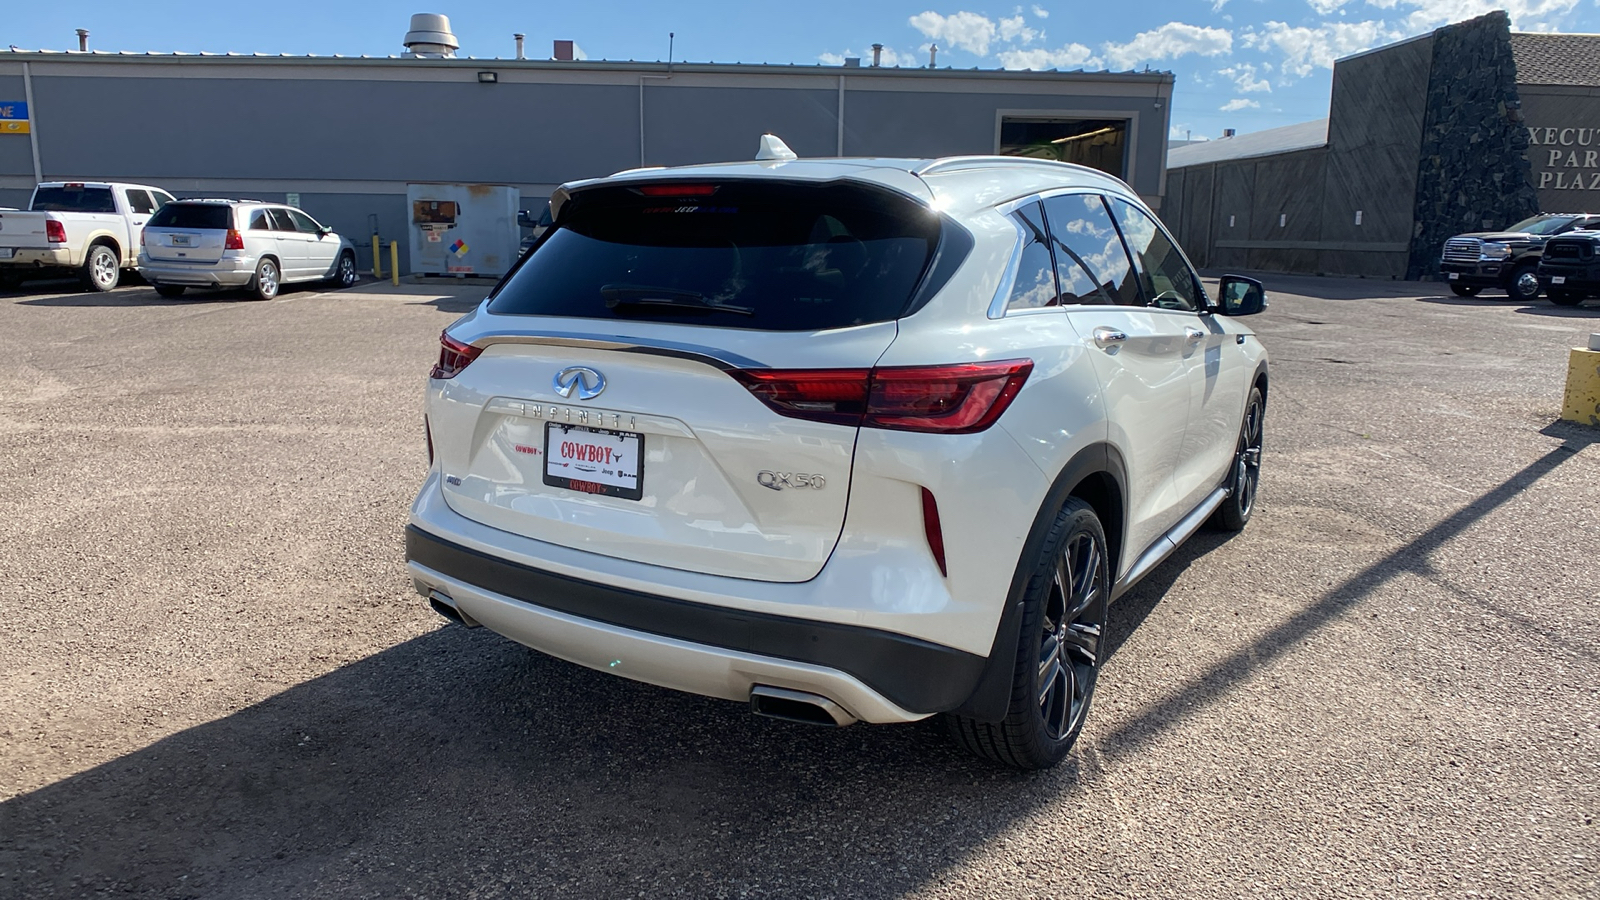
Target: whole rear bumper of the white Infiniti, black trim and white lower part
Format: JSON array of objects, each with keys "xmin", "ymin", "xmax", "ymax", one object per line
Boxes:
[{"xmin": 406, "ymin": 479, "xmax": 989, "ymax": 722}]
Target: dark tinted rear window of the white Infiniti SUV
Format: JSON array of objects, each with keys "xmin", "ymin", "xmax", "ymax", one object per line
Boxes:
[{"xmin": 490, "ymin": 183, "xmax": 942, "ymax": 331}]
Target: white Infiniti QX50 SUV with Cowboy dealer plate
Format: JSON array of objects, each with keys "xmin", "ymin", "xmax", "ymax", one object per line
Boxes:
[{"xmin": 406, "ymin": 145, "xmax": 1267, "ymax": 769}]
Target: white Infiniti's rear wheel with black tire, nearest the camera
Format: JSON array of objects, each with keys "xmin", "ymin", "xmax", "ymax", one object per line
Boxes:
[{"xmin": 946, "ymin": 498, "xmax": 1110, "ymax": 769}]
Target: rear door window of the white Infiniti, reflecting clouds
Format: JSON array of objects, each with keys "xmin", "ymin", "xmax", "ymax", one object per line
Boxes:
[{"xmin": 1045, "ymin": 194, "xmax": 1144, "ymax": 306}]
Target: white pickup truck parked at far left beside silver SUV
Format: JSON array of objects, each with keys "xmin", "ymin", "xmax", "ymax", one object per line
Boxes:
[{"xmin": 0, "ymin": 181, "xmax": 173, "ymax": 290}]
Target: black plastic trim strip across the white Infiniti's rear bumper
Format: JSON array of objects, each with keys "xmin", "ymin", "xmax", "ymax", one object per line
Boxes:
[{"xmin": 405, "ymin": 525, "xmax": 987, "ymax": 713}]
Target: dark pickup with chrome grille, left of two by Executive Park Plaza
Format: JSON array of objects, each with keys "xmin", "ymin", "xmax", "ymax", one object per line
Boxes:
[{"xmin": 1438, "ymin": 213, "xmax": 1600, "ymax": 301}]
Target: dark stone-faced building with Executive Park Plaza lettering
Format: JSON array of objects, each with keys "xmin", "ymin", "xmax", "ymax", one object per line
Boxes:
[{"xmin": 1162, "ymin": 11, "xmax": 1600, "ymax": 279}]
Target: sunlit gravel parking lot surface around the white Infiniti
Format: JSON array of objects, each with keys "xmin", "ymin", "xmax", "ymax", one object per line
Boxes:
[{"xmin": 0, "ymin": 277, "xmax": 1600, "ymax": 898}]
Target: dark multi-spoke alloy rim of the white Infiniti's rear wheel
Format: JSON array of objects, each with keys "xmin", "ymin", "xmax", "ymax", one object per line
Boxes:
[{"xmin": 1035, "ymin": 533, "xmax": 1106, "ymax": 740}]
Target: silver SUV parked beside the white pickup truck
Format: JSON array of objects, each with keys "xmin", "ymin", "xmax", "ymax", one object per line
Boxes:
[{"xmin": 139, "ymin": 200, "xmax": 357, "ymax": 299}]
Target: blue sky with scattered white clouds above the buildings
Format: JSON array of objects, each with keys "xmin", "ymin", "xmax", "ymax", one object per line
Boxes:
[{"xmin": 0, "ymin": 0, "xmax": 1600, "ymax": 138}]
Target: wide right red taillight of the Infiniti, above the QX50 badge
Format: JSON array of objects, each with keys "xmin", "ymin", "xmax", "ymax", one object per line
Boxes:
[{"xmin": 733, "ymin": 359, "xmax": 1034, "ymax": 434}]
